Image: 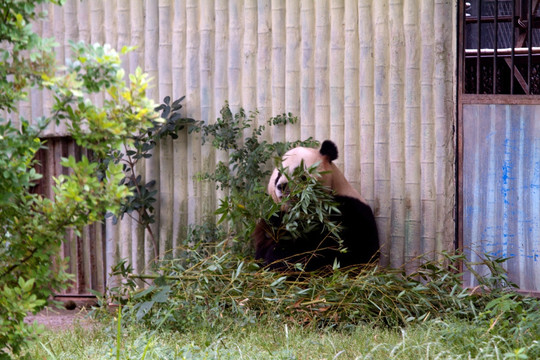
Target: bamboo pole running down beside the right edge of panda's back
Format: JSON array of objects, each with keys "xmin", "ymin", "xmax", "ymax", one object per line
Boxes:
[{"xmin": 373, "ymin": 0, "xmax": 393, "ymax": 265}]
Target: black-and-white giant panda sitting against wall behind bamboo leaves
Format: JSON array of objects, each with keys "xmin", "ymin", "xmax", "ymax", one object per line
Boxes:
[{"xmin": 253, "ymin": 140, "xmax": 379, "ymax": 271}]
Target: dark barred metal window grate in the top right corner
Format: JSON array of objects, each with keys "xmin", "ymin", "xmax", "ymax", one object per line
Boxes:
[{"xmin": 462, "ymin": 0, "xmax": 540, "ymax": 95}]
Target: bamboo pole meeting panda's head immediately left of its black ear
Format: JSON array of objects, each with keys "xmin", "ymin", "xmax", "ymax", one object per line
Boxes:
[{"xmin": 300, "ymin": 0, "xmax": 315, "ymax": 139}]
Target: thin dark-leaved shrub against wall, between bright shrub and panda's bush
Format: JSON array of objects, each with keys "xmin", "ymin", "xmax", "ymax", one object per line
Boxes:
[{"xmin": 108, "ymin": 96, "xmax": 199, "ymax": 259}]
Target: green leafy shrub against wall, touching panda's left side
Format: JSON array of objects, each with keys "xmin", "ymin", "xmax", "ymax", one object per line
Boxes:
[{"xmin": 197, "ymin": 103, "xmax": 318, "ymax": 251}]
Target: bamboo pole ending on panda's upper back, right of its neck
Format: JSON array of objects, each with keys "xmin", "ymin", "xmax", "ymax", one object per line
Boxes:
[{"xmin": 354, "ymin": 0, "xmax": 376, "ymax": 202}]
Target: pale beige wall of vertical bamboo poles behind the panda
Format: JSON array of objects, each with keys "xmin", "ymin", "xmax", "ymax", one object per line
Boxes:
[{"xmin": 9, "ymin": 0, "xmax": 456, "ymax": 280}]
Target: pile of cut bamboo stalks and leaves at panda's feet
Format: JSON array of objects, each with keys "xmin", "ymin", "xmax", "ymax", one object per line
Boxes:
[{"xmin": 104, "ymin": 252, "xmax": 519, "ymax": 327}]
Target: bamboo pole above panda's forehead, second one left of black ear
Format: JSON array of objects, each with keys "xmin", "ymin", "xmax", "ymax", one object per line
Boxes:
[{"xmin": 285, "ymin": 1, "xmax": 301, "ymax": 141}]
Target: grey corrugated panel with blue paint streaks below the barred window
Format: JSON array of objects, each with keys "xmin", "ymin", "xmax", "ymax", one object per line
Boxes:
[{"xmin": 462, "ymin": 105, "xmax": 540, "ymax": 291}]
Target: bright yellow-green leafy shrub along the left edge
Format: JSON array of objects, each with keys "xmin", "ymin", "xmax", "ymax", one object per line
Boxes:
[{"xmin": 0, "ymin": 1, "xmax": 157, "ymax": 358}]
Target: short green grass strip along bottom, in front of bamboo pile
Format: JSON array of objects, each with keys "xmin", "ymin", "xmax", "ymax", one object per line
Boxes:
[{"xmin": 29, "ymin": 319, "xmax": 536, "ymax": 360}]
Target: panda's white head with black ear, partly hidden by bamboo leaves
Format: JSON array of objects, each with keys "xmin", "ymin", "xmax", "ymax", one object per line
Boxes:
[{"xmin": 268, "ymin": 140, "xmax": 365, "ymax": 202}]
